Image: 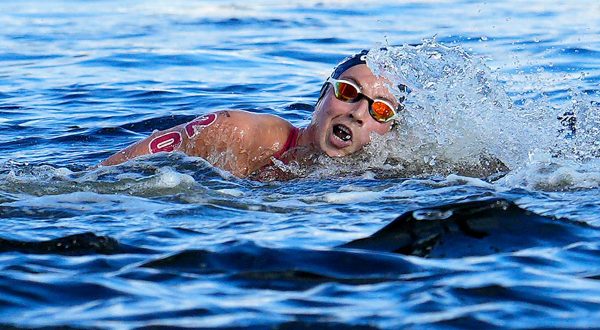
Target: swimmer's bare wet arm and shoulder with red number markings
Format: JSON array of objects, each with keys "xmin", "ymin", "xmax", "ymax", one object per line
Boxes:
[{"xmin": 100, "ymin": 111, "xmax": 289, "ymax": 177}]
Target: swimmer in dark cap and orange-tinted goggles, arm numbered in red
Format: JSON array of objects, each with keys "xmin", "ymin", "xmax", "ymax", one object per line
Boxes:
[{"xmin": 100, "ymin": 50, "xmax": 403, "ymax": 177}]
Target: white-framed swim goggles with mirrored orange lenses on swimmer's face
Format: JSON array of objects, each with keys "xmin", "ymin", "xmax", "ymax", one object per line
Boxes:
[{"xmin": 325, "ymin": 77, "xmax": 404, "ymax": 123}]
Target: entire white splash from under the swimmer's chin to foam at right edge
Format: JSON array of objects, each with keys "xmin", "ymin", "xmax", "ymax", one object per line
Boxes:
[{"xmin": 292, "ymin": 40, "xmax": 600, "ymax": 190}]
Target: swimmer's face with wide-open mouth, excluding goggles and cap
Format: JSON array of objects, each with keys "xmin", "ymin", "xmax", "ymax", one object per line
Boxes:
[{"xmin": 311, "ymin": 64, "xmax": 398, "ymax": 157}]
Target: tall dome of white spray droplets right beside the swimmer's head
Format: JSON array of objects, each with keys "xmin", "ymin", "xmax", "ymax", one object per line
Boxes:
[{"xmin": 367, "ymin": 40, "xmax": 559, "ymax": 174}]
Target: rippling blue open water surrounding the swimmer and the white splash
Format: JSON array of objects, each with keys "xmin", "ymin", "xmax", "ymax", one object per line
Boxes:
[{"xmin": 0, "ymin": 0, "xmax": 600, "ymax": 329}]
